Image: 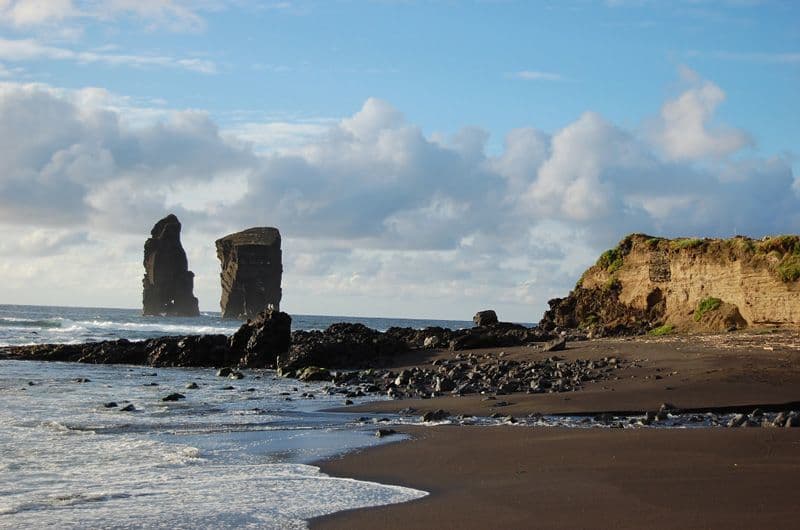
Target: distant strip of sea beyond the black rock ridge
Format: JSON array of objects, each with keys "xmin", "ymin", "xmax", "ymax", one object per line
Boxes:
[{"xmin": 0, "ymin": 305, "xmax": 472, "ymax": 346}]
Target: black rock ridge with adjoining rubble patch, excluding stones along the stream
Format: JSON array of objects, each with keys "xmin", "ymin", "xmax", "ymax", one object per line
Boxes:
[{"xmin": 0, "ymin": 310, "xmax": 608, "ymax": 397}]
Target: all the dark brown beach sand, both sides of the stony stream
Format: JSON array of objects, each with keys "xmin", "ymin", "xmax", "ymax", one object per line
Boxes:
[{"xmin": 311, "ymin": 330, "xmax": 800, "ymax": 529}]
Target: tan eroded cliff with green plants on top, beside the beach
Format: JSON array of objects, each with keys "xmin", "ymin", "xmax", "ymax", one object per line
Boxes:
[{"xmin": 540, "ymin": 234, "xmax": 800, "ymax": 335}]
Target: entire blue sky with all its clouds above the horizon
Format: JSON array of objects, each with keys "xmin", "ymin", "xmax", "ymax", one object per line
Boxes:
[{"xmin": 0, "ymin": 0, "xmax": 800, "ymax": 322}]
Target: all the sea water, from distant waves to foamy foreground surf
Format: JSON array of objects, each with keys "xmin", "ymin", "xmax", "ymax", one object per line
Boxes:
[{"xmin": 0, "ymin": 305, "xmax": 471, "ymax": 529}]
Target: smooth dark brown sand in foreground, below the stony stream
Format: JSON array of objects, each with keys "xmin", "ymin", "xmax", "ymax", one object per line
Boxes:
[{"xmin": 309, "ymin": 426, "xmax": 800, "ymax": 529}]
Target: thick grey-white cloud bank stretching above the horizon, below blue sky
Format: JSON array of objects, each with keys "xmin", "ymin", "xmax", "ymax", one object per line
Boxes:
[{"xmin": 0, "ymin": 70, "xmax": 800, "ymax": 321}]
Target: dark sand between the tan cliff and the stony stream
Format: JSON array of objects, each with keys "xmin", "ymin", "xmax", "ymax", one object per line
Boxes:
[{"xmin": 333, "ymin": 329, "xmax": 800, "ymax": 417}]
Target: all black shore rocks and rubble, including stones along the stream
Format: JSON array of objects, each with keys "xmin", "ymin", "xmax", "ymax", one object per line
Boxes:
[{"xmin": 0, "ymin": 310, "xmax": 800, "ymax": 427}]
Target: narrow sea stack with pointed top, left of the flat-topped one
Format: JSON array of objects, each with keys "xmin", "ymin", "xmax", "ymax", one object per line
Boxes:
[{"xmin": 142, "ymin": 214, "xmax": 200, "ymax": 317}]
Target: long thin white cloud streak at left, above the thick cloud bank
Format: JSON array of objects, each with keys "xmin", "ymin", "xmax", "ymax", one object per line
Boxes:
[{"xmin": 0, "ymin": 37, "xmax": 217, "ymax": 74}]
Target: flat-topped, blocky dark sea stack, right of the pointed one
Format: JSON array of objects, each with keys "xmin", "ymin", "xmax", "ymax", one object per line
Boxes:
[{"xmin": 217, "ymin": 227, "xmax": 283, "ymax": 319}]
